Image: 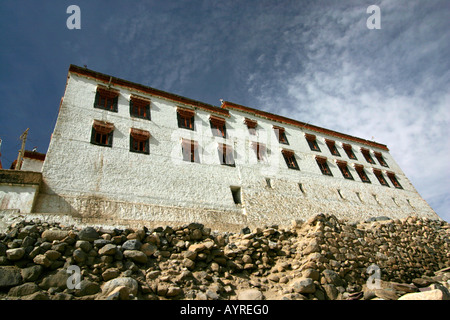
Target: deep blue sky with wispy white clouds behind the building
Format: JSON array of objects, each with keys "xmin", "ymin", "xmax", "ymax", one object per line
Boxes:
[{"xmin": 0, "ymin": 0, "xmax": 450, "ymax": 221}]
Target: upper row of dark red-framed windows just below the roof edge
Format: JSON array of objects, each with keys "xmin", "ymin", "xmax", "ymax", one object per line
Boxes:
[{"xmin": 94, "ymin": 86, "xmax": 389, "ymax": 168}]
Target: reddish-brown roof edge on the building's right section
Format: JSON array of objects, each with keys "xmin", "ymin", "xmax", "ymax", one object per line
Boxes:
[{"xmin": 222, "ymin": 101, "xmax": 389, "ymax": 151}]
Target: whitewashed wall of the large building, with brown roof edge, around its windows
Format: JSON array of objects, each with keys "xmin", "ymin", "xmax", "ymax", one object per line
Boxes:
[{"xmin": 34, "ymin": 66, "xmax": 438, "ymax": 228}]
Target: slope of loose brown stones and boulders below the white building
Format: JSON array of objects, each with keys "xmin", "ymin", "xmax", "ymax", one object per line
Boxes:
[{"xmin": 0, "ymin": 214, "xmax": 450, "ymax": 300}]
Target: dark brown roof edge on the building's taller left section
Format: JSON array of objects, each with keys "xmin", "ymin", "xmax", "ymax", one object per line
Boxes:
[{"xmin": 69, "ymin": 64, "xmax": 229, "ymax": 116}]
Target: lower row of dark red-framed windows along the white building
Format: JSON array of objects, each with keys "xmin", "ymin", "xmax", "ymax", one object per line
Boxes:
[{"xmin": 91, "ymin": 115, "xmax": 402, "ymax": 188}]
